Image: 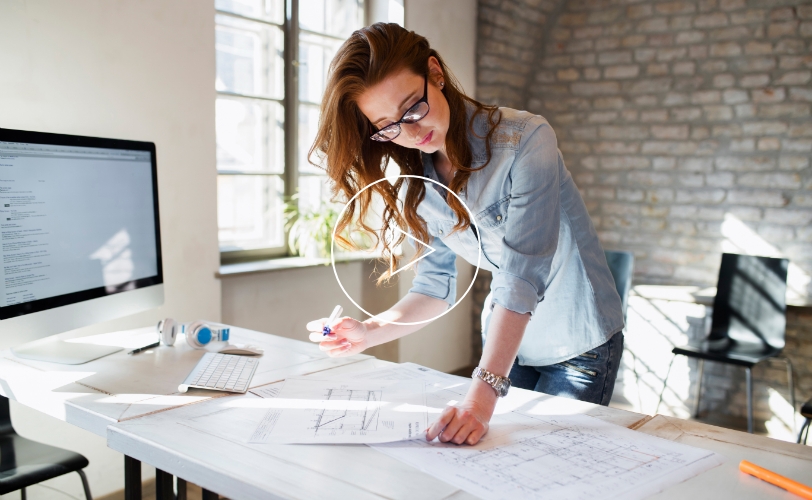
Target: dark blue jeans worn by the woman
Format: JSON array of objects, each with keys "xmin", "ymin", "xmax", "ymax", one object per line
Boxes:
[{"xmin": 510, "ymin": 332, "xmax": 623, "ymax": 406}]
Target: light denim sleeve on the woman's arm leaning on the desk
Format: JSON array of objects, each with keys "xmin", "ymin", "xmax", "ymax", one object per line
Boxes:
[{"xmin": 491, "ymin": 118, "xmax": 561, "ymax": 314}]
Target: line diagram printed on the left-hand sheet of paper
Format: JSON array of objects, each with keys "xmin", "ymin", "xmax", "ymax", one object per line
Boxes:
[{"xmin": 312, "ymin": 388, "xmax": 383, "ymax": 436}]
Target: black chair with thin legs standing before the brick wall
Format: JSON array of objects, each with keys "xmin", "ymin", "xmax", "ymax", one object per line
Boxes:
[{"xmin": 666, "ymin": 253, "xmax": 795, "ymax": 433}]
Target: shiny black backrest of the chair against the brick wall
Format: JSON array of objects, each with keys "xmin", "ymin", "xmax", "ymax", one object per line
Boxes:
[{"xmin": 708, "ymin": 253, "xmax": 789, "ymax": 349}]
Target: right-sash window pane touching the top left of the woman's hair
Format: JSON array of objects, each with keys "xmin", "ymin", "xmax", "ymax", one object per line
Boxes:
[{"xmin": 299, "ymin": 33, "xmax": 342, "ymax": 103}]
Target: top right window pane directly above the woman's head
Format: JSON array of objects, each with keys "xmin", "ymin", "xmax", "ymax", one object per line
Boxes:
[{"xmin": 299, "ymin": 0, "xmax": 364, "ymax": 38}]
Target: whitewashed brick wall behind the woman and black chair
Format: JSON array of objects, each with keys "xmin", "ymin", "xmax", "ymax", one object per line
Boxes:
[{"xmin": 476, "ymin": 0, "xmax": 812, "ymax": 434}]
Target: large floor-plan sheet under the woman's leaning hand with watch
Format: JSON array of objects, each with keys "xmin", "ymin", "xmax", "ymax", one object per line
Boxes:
[{"xmin": 373, "ymin": 412, "xmax": 723, "ymax": 500}]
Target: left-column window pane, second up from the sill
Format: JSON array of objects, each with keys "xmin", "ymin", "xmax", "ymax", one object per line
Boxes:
[{"xmin": 215, "ymin": 97, "xmax": 285, "ymax": 173}]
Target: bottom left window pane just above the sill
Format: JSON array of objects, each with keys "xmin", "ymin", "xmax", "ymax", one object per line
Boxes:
[{"xmin": 217, "ymin": 175, "xmax": 285, "ymax": 251}]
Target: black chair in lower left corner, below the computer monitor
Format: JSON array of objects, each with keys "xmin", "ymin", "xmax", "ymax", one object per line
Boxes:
[{"xmin": 0, "ymin": 396, "xmax": 92, "ymax": 500}]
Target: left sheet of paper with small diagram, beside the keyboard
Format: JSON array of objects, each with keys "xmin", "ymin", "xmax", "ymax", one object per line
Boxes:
[{"xmin": 248, "ymin": 378, "xmax": 428, "ymax": 444}]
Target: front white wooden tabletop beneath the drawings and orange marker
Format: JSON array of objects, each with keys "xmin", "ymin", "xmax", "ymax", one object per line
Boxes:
[{"xmin": 108, "ymin": 359, "xmax": 812, "ymax": 500}]
